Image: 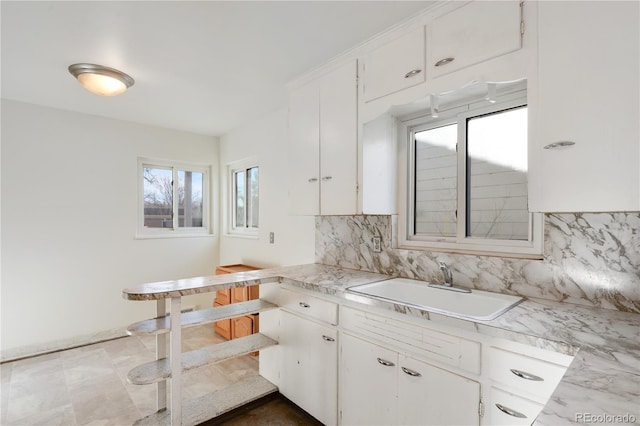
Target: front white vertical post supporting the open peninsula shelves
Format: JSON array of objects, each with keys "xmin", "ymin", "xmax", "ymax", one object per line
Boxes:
[{"xmin": 169, "ymin": 297, "xmax": 182, "ymax": 426}]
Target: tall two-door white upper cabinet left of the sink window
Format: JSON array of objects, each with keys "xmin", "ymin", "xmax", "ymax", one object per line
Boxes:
[{"xmin": 289, "ymin": 60, "xmax": 358, "ymax": 215}]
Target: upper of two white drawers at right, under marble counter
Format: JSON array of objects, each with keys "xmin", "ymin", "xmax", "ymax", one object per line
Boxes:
[{"xmin": 489, "ymin": 347, "xmax": 567, "ymax": 402}]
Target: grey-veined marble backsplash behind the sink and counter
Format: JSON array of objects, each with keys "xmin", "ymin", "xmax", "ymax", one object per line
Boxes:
[{"xmin": 315, "ymin": 212, "xmax": 640, "ymax": 313}]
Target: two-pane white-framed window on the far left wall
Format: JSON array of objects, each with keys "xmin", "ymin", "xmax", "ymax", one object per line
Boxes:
[{"xmin": 137, "ymin": 158, "xmax": 211, "ymax": 238}]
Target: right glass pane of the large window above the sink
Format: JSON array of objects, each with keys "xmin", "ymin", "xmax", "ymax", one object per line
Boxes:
[{"xmin": 467, "ymin": 107, "xmax": 531, "ymax": 241}]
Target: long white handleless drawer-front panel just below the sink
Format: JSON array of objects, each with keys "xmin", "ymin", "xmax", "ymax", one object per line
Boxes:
[{"xmin": 340, "ymin": 306, "xmax": 481, "ymax": 374}]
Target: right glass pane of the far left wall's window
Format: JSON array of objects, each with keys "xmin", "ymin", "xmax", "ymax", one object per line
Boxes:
[{"xmin": 178, "ymin": 170, "xmax": 204, "ymax": 228}]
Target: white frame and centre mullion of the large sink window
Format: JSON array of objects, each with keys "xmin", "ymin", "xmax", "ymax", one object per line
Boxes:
[{"xmin": 397, "ymin": 89, "xmax": 544, "ymax": 259}]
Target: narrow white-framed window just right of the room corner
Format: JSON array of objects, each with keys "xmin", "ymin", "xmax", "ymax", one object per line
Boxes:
[{"xmin": 227, "ymin": 159, "xmax": 260, "ymax": 236}]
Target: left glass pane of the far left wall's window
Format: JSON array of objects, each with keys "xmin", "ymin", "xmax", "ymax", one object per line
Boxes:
[{"xmin": 143, "ymin": 167, "xmax": 173, "ymax": 228}]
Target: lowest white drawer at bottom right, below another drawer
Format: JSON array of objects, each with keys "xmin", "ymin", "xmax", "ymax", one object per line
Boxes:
[{"xmin": 488, "ymin": 388, "xmax": 543, "ymax": 426}]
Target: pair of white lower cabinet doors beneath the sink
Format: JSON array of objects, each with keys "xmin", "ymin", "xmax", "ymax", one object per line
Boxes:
[{"xmin": 340, "ymin": 334, "xmax": 480, "ymax": 425}]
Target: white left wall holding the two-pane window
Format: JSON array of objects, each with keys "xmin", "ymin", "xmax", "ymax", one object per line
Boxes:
[{"xmin": 0, "ymin": 99, "xmax": 218, "ymax": 359}]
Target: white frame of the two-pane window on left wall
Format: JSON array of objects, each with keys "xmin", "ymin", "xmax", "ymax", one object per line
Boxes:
[{"xmin": 135, "ymin": 157, "xmax": 213, "ymax": 239}]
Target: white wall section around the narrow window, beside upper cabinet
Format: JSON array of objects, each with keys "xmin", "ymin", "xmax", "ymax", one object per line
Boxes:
[{"xmin": 220, "ymin": 109, "xmax": 315, "ymax": 267}]
